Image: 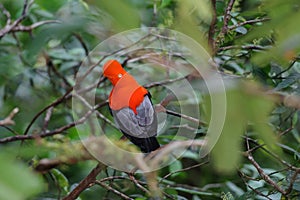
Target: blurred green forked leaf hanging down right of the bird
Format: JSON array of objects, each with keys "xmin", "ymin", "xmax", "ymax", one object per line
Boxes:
[{"xmin": 208, "ymin": 82, "xmax": 278, "ymax": 173}]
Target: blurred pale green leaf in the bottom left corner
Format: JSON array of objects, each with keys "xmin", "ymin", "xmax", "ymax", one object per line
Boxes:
[{"xmin": 0, "ymin": 154, "xmax": 44, "ymax": 200}]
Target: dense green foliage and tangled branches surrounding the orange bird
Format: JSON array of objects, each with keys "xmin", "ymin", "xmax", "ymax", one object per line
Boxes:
[{"xmin": 0, "ymin": 0, "xmax": 300, "ymax": 200}]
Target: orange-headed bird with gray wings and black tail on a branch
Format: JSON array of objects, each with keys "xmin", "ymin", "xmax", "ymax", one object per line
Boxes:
[{"xmin": 103, "ymin": 60, "xmax": 160, "ymax": 153}]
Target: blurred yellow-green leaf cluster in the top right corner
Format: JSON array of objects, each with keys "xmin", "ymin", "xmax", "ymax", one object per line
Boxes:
[{"xmin": 238, "ymin": 0, "xmax": 300, "ymax": 65}]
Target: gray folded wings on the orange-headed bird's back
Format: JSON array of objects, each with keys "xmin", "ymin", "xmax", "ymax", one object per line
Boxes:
[{"xmin": 113, "ymin": 96, "xmax": 157, "ymax": 138}]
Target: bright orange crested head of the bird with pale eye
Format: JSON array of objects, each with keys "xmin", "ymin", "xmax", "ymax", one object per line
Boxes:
[{"xmin": 103, "ymin": 60, "xmax": 126, "ymax": 85}]
